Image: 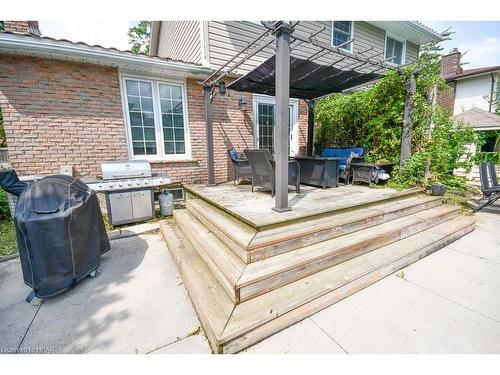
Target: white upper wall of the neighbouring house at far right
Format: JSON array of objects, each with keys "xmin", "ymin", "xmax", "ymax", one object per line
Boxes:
[{"xmin": 453, "ymin": 74, "xmax": 498, "ymax": 115}]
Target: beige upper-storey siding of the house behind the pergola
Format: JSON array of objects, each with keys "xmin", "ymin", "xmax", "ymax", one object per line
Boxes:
[{"xmin": 208, "ymin": 21, "xmax": 419, "ymax": 74}]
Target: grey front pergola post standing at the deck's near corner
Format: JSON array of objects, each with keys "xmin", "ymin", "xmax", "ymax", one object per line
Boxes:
[{"xmin": 273, "ymin": 21, "xmax": 293, "ymax": 212}]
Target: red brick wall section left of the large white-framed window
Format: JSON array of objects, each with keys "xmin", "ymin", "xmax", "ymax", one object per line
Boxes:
[{"xmin": 0, "ymin": 55, "xmax": 127, "ymax": 176}]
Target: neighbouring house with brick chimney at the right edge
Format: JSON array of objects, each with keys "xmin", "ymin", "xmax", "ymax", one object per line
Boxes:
[{"xmin": 439, "ymin": 49, "xmax": 500, "ymax": 179}]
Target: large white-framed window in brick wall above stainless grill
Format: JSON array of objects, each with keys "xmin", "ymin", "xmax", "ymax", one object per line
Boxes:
[{"xmin": 122, "ymin": 76, "xmax": 191, "ymax": 160}]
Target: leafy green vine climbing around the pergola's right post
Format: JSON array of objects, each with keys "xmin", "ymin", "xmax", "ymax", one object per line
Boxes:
[{"xmin": 315, "ymin": 32, "xmax": 477, "ymax": 189}]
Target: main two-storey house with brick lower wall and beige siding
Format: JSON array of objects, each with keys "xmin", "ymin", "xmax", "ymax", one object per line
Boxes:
[{"xmin": 0, "ymin": 21, "xmax": 440, "ymax": 182}]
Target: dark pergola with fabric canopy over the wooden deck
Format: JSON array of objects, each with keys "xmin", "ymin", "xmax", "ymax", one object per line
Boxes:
[{"xmin": 203, "ymin": 21, "xmax": 404, "ymax": 212}]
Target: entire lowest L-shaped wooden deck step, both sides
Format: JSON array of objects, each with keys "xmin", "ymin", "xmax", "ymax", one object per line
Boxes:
[{"xmin": 160, "ymin": 216, "xmax": 475, "ymax": 353}]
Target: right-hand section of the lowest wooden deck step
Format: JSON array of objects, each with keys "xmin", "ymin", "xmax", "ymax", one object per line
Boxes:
[{"xmin": 219, "ymin": 216, "xmax": 475, "ymax": 353}]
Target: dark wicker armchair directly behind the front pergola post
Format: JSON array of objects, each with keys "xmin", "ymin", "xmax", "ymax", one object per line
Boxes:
[{"xmin": 244, "ymin": 149, "xmax": 300, "ymax": 196}]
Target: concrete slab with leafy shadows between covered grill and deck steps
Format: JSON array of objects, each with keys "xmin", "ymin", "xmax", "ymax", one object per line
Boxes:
[{"xmin": 15, "ymin": 235, "xmax": 200, "ymax": 353}]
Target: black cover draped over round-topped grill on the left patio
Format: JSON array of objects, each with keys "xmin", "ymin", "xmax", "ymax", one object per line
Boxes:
[{"xmin": 15, "ymin": 175, "xmax": 110, "ymax": 298}]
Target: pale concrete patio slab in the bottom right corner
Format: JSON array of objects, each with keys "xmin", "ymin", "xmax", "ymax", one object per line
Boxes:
[{"xmin": 311, "ymin": 274, "xmax": 500, "ymax": 354}]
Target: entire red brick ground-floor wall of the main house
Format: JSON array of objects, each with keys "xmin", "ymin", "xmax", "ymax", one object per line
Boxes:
[{"xmin": 0, "ymin": 55, "xmax": 307, "ymax": 182}]
